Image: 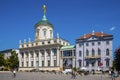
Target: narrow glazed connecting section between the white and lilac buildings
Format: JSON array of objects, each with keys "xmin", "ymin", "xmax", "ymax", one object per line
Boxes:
[{"xmin": 60, "ymin": 45, "xmax": 76, "ymax": 70}]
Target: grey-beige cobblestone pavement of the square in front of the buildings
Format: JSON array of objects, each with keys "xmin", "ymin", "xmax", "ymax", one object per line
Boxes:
[{"xmin": 0, "ymin": 72, "xmax": 120, "ymax": 80}]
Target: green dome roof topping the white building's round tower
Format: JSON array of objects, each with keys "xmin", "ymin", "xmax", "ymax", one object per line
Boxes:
[{"xmin": 35, "ymin": 15, "xmax": 53, "ymax": 28}]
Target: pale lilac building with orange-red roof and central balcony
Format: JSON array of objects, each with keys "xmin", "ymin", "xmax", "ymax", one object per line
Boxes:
[{"xmin": 76, "ymin": 31, "xmax": 113, "ymax": 71}]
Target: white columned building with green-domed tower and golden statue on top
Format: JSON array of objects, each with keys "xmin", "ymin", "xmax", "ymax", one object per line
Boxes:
[{"xmin": 19, "ymin": 5, "xmax": 69, "ymax": 71}]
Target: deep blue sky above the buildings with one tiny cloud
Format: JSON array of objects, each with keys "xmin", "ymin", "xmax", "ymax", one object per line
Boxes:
[{"xmin": 0, "ymin": 0, "xmax": 120, "ymax": 51}]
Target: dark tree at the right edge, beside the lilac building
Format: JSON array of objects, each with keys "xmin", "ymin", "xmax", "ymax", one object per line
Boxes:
[{"xmin": 115, "ymin": 47, "xmax": 120, "ymax": 72}]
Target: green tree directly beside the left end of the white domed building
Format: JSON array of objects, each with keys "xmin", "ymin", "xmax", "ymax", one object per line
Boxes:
[{"xmin": 8, "ymin": 51, "xmax": 19, "ymax": 69}]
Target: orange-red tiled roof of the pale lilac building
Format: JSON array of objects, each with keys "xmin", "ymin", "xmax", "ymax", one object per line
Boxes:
[{"xmin": 77, "ymin": 32, "xmax": 112, "ymax": 40}]
